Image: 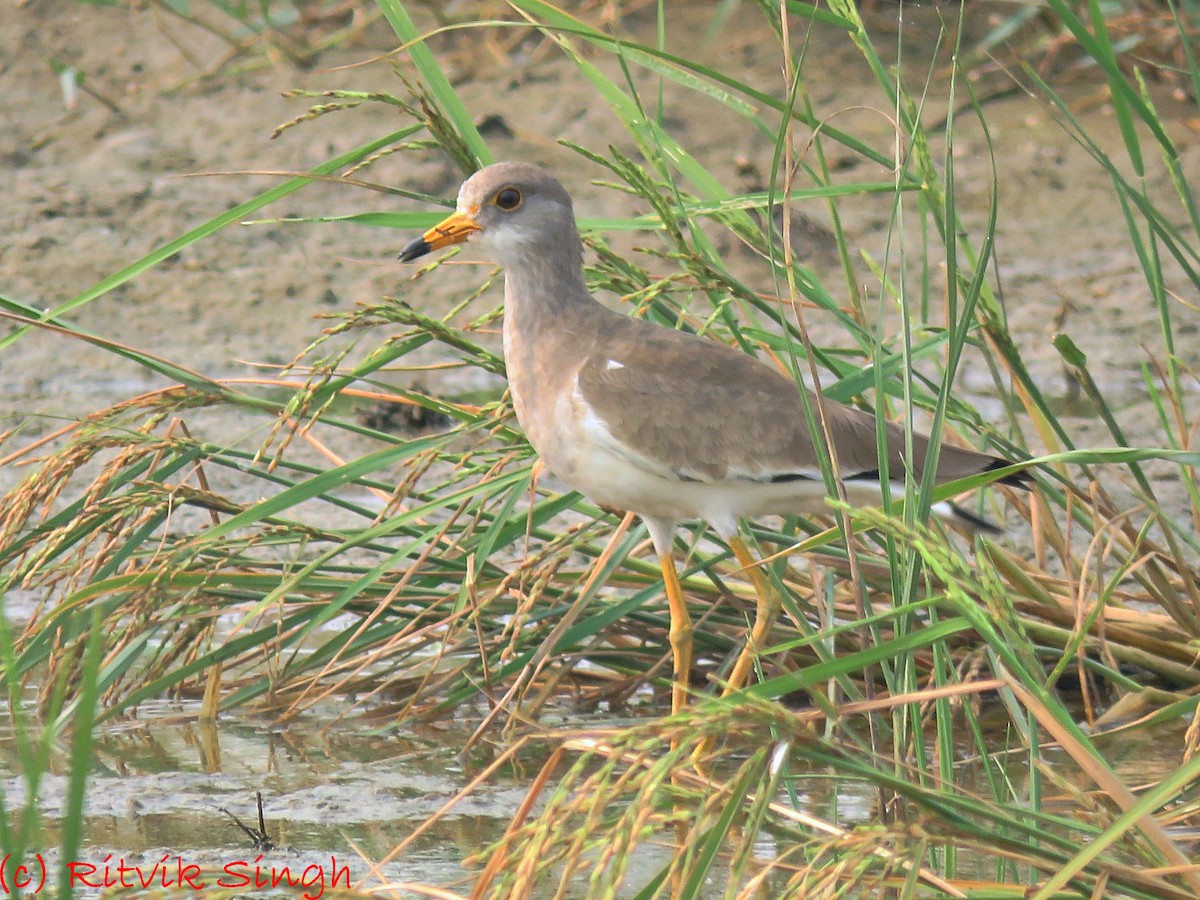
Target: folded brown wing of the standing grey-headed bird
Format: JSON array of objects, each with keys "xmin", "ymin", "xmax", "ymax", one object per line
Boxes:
[{"xmin": 577, "ymin": 318, "xmax": 1004, "ymax": 481}]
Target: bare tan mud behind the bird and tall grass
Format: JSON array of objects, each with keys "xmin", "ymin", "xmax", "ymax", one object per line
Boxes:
[{"xmin": 0, "ymin": 2, "xmax": 1200, "ymax": 442}]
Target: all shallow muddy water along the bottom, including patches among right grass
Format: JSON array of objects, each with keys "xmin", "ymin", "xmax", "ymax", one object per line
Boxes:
[{"xmin": 0, "ymin": 703, "xmax": 1182, "ymax": 898}]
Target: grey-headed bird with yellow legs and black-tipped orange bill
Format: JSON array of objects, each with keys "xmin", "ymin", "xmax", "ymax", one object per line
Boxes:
[{"xmin": 398, "ymin": 161, "xmax": 1030, "ymax": 713}]
